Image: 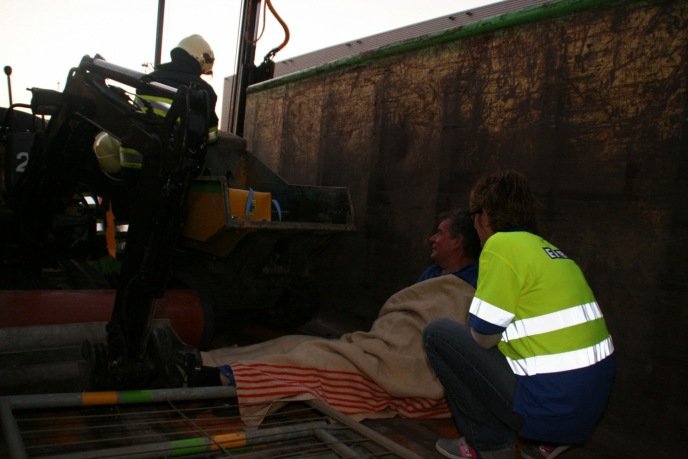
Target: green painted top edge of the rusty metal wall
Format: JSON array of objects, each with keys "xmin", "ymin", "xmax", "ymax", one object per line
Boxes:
[{"xmin": 248, "ymin": 0, "xmax": 653, "ymax": 93}]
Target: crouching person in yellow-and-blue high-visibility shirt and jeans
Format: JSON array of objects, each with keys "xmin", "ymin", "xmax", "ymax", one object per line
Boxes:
[{"xmin": 423, "ymin": 170, "xmax": 615, "ymax": 459}]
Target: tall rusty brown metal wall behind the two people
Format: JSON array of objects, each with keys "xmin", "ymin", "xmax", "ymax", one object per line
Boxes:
[{"xmin": 245, "ymin": 1, "xmax": 688, "ymax": 457}]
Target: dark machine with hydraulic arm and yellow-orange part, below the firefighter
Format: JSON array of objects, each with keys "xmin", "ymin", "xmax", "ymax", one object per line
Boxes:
[{"xmin": 0, "ymin": 56, "xmax": 354, "ymax": 388}]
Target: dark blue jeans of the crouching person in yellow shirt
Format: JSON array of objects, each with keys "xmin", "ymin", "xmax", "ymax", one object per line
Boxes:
[{"xmin": 423, "ymin": 319, "xmax": 523, "ymax": 451}]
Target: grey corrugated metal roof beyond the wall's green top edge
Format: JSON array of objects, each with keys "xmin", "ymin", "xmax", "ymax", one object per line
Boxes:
[{"xmin": 274, "ymin": 0, "xmax": 552, "ymax": 77}]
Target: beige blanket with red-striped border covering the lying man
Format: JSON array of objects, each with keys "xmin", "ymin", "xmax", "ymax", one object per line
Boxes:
[{"xmin": 203, "ymin": 275, "xmax": 474, "ymax": 425}]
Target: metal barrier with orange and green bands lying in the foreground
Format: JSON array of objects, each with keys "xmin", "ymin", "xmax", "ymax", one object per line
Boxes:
[{"xmin": 0, "ymin": 387, "xmax": 419, "ymax": 459}]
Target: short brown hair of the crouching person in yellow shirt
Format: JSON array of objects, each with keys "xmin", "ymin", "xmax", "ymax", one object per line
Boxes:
[{"xmin": 469, "ymin": 170, "xmax": 538, "ymax": 233}]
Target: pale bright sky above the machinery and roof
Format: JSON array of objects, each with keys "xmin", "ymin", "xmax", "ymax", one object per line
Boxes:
[{"xmin": 0, "ymin": 0, "xmax": 497, "ymax": 124}]
